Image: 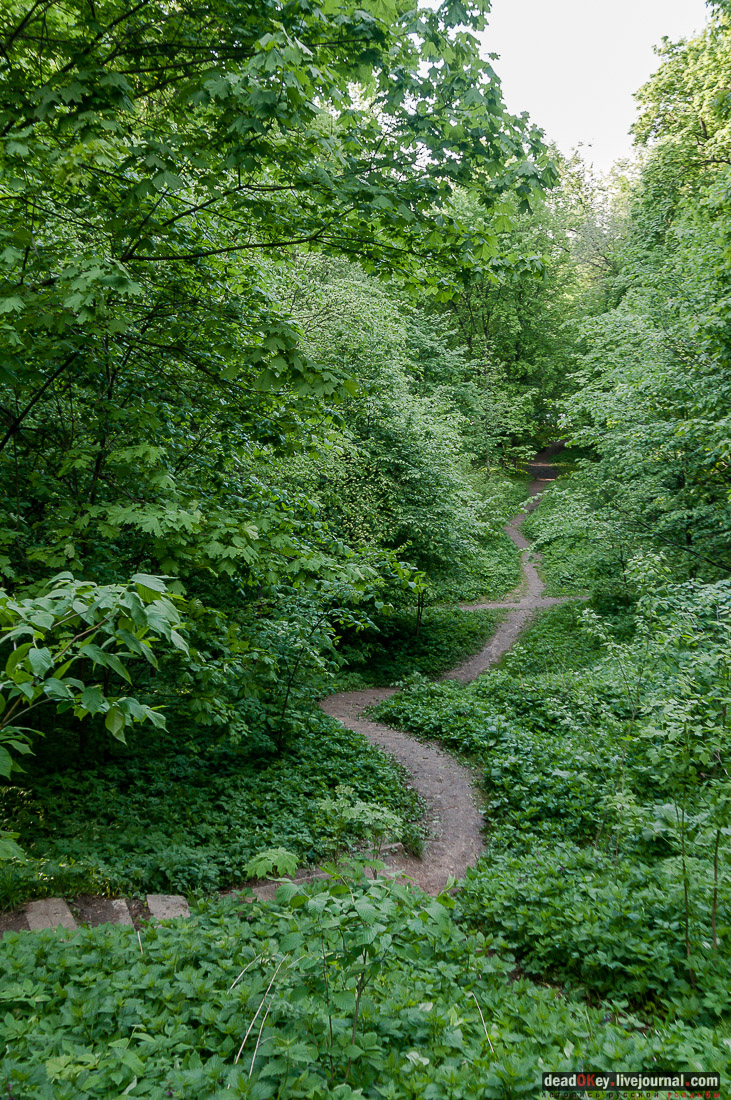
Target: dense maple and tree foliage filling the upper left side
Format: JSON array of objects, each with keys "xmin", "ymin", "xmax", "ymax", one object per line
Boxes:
[{"xmin": 0, "ymin": 0, "xmax": 555, "ymax": 891}]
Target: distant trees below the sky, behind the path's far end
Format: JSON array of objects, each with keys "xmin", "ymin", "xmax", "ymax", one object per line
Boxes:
[{"xmin": 445, "ymin": 185, "xmax": 584, "ymax": 463}]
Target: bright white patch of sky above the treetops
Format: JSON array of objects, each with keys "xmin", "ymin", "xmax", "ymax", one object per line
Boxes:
[{"xmin": 481, "ymin": 0, "xmax": 710, "ymax": 173}]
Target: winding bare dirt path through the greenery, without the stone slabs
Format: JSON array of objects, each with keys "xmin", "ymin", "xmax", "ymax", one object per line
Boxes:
[{"xmin": 320, "ymin": 443, "xmax": 571, "ymax": 894}]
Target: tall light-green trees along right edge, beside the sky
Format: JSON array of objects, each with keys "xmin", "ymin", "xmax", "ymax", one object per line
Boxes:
[{"xmin": 554, "ymin": 17, "xmax": 731, "ymax": 581}]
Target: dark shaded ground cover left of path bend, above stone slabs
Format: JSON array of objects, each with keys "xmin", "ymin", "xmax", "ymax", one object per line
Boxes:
[{"xmin": 0, "ymin": 712, "xmax": 420, "ymax": 908}]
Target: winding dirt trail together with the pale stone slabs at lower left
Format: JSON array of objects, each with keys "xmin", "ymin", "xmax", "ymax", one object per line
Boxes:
[{"xmin": 0, "ymin": 443, "xmax": 572, "ymax": 935}]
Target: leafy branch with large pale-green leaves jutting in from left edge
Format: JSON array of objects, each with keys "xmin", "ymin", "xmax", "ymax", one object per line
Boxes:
[{"xmin": 0, "ymin": 573, "xmax": 188, "ymax": 858}]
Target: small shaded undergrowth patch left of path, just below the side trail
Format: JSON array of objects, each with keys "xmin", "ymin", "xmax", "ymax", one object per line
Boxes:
[{"xmin": 337, "ymin": 607, "xmax": 501, "ymax": 691}]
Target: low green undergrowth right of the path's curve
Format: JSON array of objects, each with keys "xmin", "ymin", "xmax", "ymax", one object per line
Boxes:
[{"xmin": 378, "ymin": 606, "xmax": 731, "ymax": 1024}]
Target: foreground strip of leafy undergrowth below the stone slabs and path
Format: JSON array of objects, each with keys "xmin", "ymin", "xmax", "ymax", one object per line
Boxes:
[{"xmin": 0, "ymin": 872, "xmax": 731, "ymax": 1100}]
